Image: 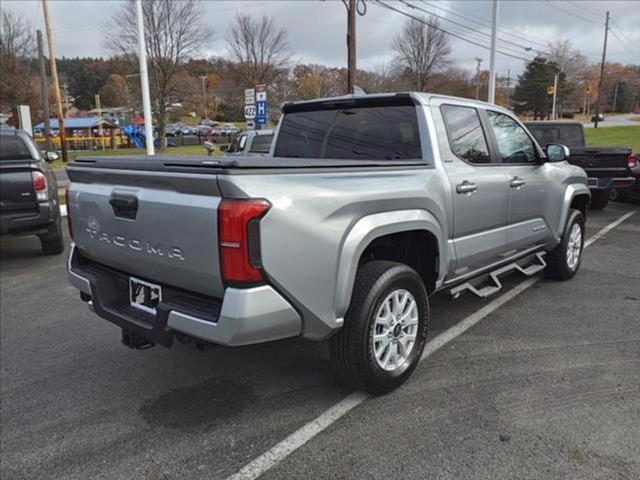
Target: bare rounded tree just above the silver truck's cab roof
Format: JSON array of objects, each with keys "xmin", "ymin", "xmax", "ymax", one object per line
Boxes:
[{"xmin": 391, "ymin": 17, "xmax": 451, "ymax": 91}]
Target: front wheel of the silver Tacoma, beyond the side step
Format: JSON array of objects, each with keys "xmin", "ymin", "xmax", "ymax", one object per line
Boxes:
[{"xmin": 545, "ymin": 209, "xmax": 584, "ymax": 280}]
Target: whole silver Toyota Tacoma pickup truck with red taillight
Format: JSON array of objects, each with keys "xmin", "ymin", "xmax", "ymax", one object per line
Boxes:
[{"xmin": 67, "ymin": 93, "xmax": 590, "ymax": 392}]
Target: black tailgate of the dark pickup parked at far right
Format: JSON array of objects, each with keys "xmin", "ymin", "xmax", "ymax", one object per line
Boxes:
[{"xmin": 569, "ymin": 147, "xmax": 631, "ymax": 178}]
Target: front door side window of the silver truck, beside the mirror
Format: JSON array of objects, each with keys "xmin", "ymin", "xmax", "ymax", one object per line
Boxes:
[{"xmin": 487, "ymin": 110, "xmax": 538, "ymax": 164}]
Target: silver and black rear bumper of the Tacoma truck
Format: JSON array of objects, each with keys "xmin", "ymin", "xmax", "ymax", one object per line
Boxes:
[{"xmin": 67, "ymin": 243, "xmax": 302, "ymax": 347}]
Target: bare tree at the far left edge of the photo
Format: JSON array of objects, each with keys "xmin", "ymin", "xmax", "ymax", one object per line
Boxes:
[{"xmin": 0, "ymin": 8, "xmax": 36, "ymax": 123}]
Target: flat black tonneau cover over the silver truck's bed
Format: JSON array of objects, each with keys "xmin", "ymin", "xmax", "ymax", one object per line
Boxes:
[{"xmin": 69, "ymin": 155, "xmax": 426, "ymax": 173}]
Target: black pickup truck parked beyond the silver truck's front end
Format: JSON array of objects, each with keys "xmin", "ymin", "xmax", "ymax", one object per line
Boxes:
[{"xmin": 524, "ymin": 121, "xmax": 636, "ymax": 210}]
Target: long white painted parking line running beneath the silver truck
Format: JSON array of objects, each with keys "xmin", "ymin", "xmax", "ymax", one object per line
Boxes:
[{"xmin": 227, "ymin": 210, "xmax": 636, "ymax": 480}]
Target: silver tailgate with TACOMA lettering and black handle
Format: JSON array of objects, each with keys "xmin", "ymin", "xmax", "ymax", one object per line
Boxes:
[{"xmin": 67, "ymin": 167, "xmax": 224, "ymax": 297}]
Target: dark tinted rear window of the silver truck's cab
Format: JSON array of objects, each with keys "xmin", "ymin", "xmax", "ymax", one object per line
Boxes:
[{"xmin": 275, "ymin": 105, "xmax": 422, "ymax": 160}]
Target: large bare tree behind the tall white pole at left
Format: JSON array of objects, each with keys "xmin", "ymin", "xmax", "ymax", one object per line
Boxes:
[{"xmin": 103, "ymin": 0, "xmax": 213, "ymax": 148}]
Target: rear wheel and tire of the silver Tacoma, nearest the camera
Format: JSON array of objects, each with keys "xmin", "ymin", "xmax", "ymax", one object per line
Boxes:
[{"xmin": 331, "ymin": 261, "xmax": 429, "ymax": 394}]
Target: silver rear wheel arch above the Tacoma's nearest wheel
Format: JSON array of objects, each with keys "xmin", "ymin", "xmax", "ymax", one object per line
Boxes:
[{"xmin": 335, "ymin": 209, "xmax": 447, "ymax": 318}]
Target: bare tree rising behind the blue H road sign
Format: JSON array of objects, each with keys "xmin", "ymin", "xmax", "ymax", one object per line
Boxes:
[{"xmin": 227, "ymin": 14, "xmax": 290, "ymax": 86}]
